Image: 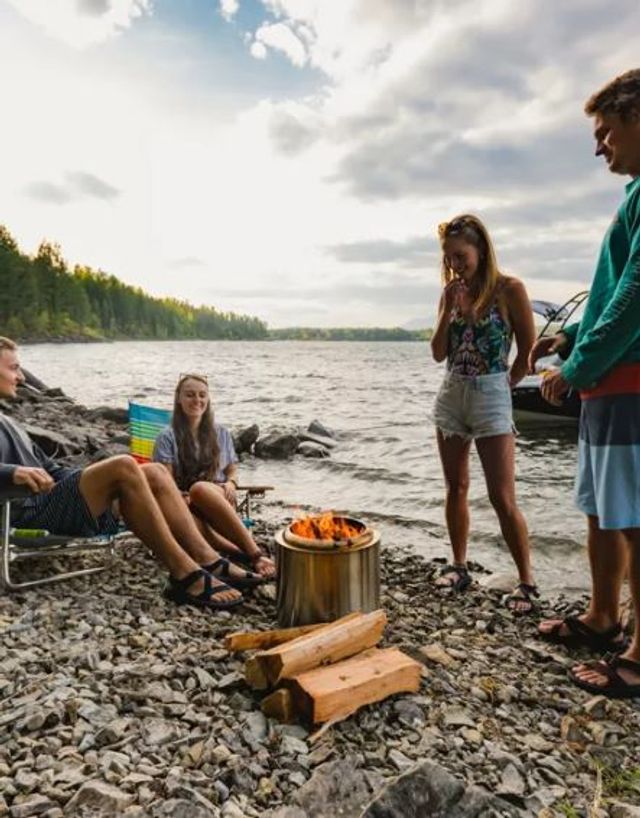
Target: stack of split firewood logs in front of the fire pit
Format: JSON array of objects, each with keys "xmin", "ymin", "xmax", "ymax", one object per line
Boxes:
[{"xmin": 225, "ymin": 610, "xmax": 421, "ymax": 724}]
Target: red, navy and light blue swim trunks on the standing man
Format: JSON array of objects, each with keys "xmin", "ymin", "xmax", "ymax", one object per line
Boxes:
[{"xmin": 575, "ymin": 363, "xmax": 640, "ymax": 530}]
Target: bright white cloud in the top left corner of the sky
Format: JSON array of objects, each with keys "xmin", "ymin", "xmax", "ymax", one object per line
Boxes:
[{"xmin": 8, "ymin": 0, "xmax": 153, "ymax": 48}]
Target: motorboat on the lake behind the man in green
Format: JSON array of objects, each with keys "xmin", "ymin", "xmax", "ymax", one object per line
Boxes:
[{"xmin": 511, "ymin": 290, "xmax": 589, "ymax": 423}]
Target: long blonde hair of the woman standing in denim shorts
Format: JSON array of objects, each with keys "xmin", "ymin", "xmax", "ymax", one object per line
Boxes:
[{"xmin": 438, "ymin": 213, "xmax": 501, "ymax": 314}]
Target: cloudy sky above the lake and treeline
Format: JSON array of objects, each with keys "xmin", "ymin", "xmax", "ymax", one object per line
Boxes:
[{"xmin": 0, "ymin": 0, "xmax": 640, "ymax": 327}]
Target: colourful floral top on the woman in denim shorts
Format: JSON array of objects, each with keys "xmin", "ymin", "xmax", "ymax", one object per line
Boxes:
[{"xmin": 447, "ymin": 301, "xmax": 512, "ymax": 377}]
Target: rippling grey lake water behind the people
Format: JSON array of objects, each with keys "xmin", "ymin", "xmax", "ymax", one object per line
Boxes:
[{"xmin": 21, "ymin": 341, "xmax": 588, "ymax": 592}]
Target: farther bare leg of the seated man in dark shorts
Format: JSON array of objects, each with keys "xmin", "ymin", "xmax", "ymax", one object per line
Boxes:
[{"xmin": 141, "ymin": 463, "xmax": 262, "ymax": 578}]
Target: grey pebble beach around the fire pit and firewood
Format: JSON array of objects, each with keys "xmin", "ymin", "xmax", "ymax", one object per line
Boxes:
[{"xmin": 0, "ymin": 380, "xmax": 640, "ymax": 818}]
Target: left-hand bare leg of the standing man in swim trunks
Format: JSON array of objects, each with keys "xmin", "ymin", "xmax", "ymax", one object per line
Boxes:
[{"xmin": 539, "ymin": 516, "xmax": 628, "ymax": 636}]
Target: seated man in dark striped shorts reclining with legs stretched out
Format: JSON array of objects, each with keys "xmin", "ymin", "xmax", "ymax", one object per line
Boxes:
[{"xmin": 0, "ymin": 337, "xmax": 261, "ymax": 609}]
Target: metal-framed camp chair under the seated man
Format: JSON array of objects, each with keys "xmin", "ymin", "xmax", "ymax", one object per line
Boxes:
[{"xmin": 0, "ymin": 486, "xmax": 116, "ymax": 591}]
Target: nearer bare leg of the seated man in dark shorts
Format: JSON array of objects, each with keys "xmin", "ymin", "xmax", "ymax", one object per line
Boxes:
[{"xmin": 79, "ymin": 455, "xmax": 240, "ymax": 602}]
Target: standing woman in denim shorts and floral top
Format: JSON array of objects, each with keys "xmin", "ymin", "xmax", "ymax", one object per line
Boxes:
[{"xmin": 431, "ymin": 215, "xmax": 538, "ymax": 613}]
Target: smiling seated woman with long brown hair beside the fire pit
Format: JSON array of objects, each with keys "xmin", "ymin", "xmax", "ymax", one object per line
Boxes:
[{"xmin": 153, "ymin": 374, "xmax": 275, "ymax": 576}]
